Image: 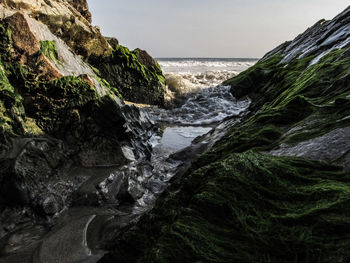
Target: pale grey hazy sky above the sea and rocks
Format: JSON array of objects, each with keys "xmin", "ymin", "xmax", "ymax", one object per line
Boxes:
[{"xmin": 87, "ymin": 0, "xmax": 349, "ymax": 58}]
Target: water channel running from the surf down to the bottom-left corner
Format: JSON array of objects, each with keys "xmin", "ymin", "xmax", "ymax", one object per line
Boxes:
[{"xmin": 0, "ymin": 59, "xmax": 256, "ymax": 263}]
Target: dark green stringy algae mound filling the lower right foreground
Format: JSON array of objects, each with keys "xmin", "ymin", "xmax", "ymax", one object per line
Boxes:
[{"xmin": 108, "ymin": 151, "xmax": 350, "ymax": 262}]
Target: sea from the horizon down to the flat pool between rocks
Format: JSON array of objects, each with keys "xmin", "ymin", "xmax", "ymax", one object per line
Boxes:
[{"xmin": 147, "ymin": 58, "xmax": 258, "ymax": 154}]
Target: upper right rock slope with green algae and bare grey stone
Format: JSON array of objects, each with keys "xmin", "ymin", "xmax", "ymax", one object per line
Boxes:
[{"xmin": 220, "ymin": 5, "xmax": 350, "ymax": 168}]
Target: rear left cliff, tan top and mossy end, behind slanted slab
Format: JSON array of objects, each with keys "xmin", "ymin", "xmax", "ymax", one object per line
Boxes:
[{"xmin": 0, "ymin": 0, "xmax": 165, "ymax": 105}]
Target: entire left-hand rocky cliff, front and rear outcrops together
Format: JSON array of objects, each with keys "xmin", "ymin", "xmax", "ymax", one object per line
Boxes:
[{"xmin": 0, "ymin": 0, "xmax": 164, "ymax": 262}]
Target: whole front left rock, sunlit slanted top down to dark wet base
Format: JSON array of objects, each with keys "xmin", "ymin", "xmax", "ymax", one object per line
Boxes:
[{"xmin": 0, "ymin": 7, "xmax": 155, "ymax": 262}]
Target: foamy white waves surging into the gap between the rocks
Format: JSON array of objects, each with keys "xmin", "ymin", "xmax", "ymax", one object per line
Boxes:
[{"xmin": 148, "ymin": 59, "xmax": 256, "ymax": 126}]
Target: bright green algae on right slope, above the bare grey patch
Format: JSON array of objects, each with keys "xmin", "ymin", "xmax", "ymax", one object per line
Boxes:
[{"xmin": 219, "ymin": 49, "xmax": 350, "ymax": 151}]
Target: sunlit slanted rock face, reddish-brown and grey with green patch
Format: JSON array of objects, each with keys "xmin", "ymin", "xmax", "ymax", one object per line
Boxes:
[{"xmin": 4, "ymin": 12, "xmax": 106, "ymax": 86}]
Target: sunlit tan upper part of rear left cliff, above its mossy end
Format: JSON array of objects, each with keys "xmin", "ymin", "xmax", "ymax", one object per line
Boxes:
[{"xmin": 0, "ymin": 0, "xmax": 112, "ymax": 59}]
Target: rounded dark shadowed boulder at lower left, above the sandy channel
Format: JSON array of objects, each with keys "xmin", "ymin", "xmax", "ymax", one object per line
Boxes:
[{"xmin": 0, "ymin": 139, "xmax": 70, "ymax": 210}]
